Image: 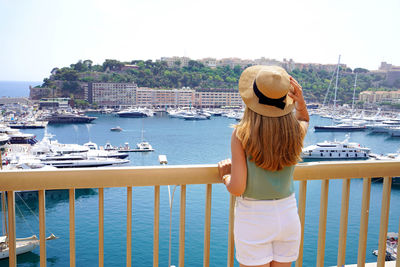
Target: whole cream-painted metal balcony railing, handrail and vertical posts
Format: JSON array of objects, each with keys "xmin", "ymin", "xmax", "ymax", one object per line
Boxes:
[{"xmin": 0, "ymin": 161, "xmax": 400, "ymax": 267}]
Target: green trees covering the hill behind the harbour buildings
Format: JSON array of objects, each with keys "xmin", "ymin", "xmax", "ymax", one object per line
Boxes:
[{"xmin": 38, "ymin": 59, "xmax": 396, "ymax": 104}]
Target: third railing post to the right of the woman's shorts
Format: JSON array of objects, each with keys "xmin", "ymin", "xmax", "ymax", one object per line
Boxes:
[{"xmin": 337, "ymin": 179, "xmax": 350, "ymax": 266}]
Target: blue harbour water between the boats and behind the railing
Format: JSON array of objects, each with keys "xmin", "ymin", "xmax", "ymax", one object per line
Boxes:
[{"xmin": 0, "ymin": 113, "xmax": 400, "ymax": 266}]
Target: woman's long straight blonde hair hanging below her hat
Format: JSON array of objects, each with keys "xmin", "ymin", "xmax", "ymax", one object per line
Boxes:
[{"xmin": 234, "ymin": 107, "xmax": 306, "ymax": 171}]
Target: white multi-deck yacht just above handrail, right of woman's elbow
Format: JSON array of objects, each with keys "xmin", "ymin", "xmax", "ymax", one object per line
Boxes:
[{"xmin": 301, "ymin": 137, "xmax": 370, "ymax": 161}]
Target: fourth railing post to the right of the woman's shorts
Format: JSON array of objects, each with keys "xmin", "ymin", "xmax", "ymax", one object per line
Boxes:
[{"xmin": 357, "ymin": 178, "xmax": 371, "ymax": 266}]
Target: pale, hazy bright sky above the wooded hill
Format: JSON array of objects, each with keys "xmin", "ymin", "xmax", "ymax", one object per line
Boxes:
[{"xmin": 0, "ymin": 0, "xmax": 400, "ymax": 81}]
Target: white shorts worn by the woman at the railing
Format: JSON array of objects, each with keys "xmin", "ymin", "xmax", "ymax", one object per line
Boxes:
[{"xmin": 234, "ymin": 194, "xmax": 301, "ymax": 266}]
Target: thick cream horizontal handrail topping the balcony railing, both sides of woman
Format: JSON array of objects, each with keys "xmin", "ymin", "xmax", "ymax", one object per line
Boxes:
[{"xmin": 0, "ymin": 160, "xmax": 400, "ymax": 191}]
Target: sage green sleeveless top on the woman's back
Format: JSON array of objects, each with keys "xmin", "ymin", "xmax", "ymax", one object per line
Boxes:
[{"xmin": 243, "ymin": 158, "xmax": 295, "ymax": 200}]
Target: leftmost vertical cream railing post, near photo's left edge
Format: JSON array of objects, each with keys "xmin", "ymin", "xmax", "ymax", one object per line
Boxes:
[{"xmin": 3, "ymin": 191, "xmax": 17, "ymax": 267}]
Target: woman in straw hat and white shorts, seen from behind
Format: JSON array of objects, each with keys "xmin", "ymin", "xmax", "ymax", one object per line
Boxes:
[{"xmin": 218, "ymin": 66, "xmax": 309, "ymax": 267}]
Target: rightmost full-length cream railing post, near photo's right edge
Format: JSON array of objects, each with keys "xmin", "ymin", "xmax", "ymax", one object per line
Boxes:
[{"xmin": 378, "ymin": 177, "xmax": 392, "ymax": 267}]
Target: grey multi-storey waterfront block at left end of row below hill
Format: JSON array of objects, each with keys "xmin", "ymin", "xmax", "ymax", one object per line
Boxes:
[{"xmin": 85, "ymin": 83, "xmax": 137, "ymax": 107}]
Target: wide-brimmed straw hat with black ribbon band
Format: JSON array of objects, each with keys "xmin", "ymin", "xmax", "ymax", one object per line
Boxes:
[{"xmin": 239, "ymin": 66, "xmax": 294, "ymax": 117}]
